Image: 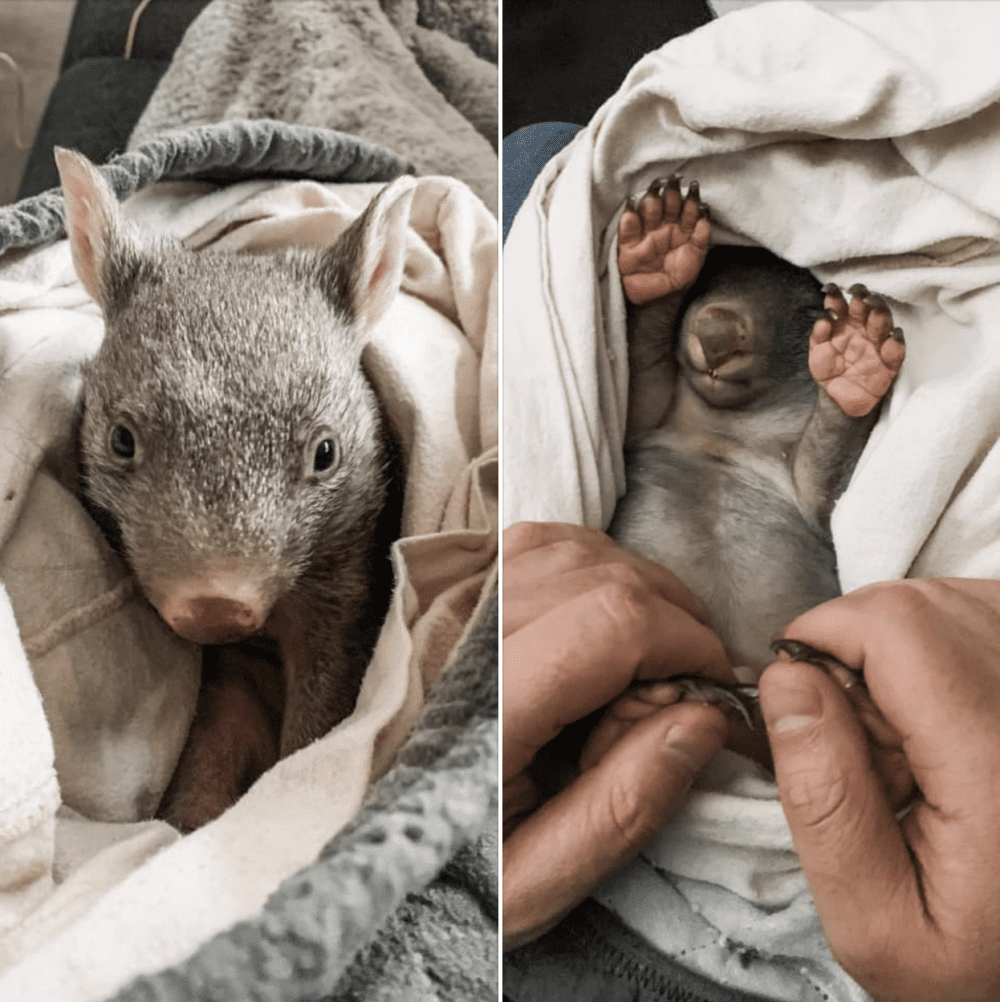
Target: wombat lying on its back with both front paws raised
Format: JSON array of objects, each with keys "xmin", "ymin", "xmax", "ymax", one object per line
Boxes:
[{"xmin": 609, "ymin": 179, "xmax": 905, "ymax": 681}]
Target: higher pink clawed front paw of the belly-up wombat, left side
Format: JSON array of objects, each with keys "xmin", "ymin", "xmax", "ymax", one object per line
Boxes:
[{"xmin": 618, "ymin": 176, "xmax": 711, "ymax": 306}]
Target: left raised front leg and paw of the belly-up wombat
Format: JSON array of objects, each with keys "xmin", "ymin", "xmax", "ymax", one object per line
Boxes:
[{"xmin": 618, "ymin": 176, "xmax": 711, "ymax": 442}]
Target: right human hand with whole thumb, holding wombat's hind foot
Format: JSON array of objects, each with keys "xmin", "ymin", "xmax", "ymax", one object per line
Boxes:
[{"xmin": 760, "ymin": 579, "xmax": 1000, "ymax": 1002}]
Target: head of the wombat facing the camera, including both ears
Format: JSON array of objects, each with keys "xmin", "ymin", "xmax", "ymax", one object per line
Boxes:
[{"xmin": 59, "ymin": 151, "xmax": 412, "ymax": 643}]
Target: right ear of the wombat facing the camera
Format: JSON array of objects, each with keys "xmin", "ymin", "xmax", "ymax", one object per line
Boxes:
[{"xmin": 321, "ymin": 177, "xmax": 416, "ymax": 329}]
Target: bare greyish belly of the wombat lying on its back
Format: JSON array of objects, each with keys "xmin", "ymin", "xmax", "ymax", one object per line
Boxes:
[{"xmin": 609, "ymin": 444, "xmax": 840, "ymax": 671}]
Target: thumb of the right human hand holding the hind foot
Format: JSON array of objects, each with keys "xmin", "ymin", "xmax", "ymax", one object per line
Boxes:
[{"xmin": 759, "ymin": 661, "xmax": 923, "ymax": 971}]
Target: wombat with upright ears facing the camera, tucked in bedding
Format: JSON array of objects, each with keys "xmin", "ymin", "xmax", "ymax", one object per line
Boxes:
[{"xmin": 56, "ymin": 150, "xmax": 413, "ymax": 829}]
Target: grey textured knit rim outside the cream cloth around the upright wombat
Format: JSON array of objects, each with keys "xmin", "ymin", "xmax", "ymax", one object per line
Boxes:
[{"xmin": 0, "ymin": 121, "xmax": 497, "ymax": 1002}]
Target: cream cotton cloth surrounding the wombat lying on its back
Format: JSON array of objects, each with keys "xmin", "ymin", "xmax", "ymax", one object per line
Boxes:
[{"xmin": 503, "ymin": 2, "xmax": 1000, "ymax": 1000}]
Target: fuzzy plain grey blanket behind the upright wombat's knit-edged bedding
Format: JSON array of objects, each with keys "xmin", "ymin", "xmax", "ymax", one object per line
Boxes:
[{"xmin": 129, "ymin": 0, "xmax": 498, "ymax": 213}]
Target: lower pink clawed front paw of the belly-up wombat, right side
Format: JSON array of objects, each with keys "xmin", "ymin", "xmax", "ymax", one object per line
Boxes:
[{"xmin": 809, "ymin": 283, "xmax": 906, "ymax": 418}]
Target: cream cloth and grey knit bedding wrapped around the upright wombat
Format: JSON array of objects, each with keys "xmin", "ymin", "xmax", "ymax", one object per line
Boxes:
[{"xmin": 0, "ymin": 95, "xmax": 497, "ymax": 1000}]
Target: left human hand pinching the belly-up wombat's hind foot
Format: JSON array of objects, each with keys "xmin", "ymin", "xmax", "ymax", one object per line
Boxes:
[{"xmin": 503, "ymin": 523, "xmax": 732, "ymax": 949}]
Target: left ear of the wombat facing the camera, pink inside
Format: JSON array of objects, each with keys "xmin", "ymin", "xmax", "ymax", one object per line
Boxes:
[{"xmin": 55, "ymin": 146, "xmax": 139, "ymax": 309}]
